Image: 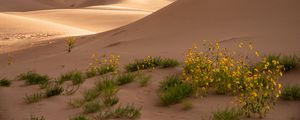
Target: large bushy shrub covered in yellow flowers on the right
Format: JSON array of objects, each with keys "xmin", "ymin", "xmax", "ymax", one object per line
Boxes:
[{"xmin": 183, "ymin": 42, "xmax": 282, "ymax": 117}]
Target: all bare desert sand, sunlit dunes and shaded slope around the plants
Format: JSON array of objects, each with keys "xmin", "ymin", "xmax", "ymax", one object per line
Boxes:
[{"xmin": 0, "ymin": 0, "xmax": 300, "ymax": 120}]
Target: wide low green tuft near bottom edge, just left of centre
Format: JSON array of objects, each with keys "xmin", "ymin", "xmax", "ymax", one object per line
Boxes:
[{"xmin": 113, "ymin": 105, "xmax": 141, "ymax": 119}]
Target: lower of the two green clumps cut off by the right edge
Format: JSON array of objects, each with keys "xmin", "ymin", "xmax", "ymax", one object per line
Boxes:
[{"xmin": 281, "ymin": 85, "xmax": 300, "ymax": 100}]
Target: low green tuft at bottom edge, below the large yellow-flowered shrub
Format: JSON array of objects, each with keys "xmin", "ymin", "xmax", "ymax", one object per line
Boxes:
[{"xmin": 213, "ymin": 108, "xmax": 243, "ymax": 120}]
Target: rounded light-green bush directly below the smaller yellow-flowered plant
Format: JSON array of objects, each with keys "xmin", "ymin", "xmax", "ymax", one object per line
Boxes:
[{"xmin": 96, "ymin": 78, "xmax": 119, "ymax": 97}]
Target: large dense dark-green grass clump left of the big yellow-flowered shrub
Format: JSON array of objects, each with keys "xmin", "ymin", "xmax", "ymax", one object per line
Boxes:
[{"xmin": 158, "ymin": 75, "xmax": 194, "ymax": 106}]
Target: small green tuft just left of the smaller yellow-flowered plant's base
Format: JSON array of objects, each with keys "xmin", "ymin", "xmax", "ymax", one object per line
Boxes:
[{"xmin": 59, "ymin": 71, "xmax": 85, "ymax": 85}]
